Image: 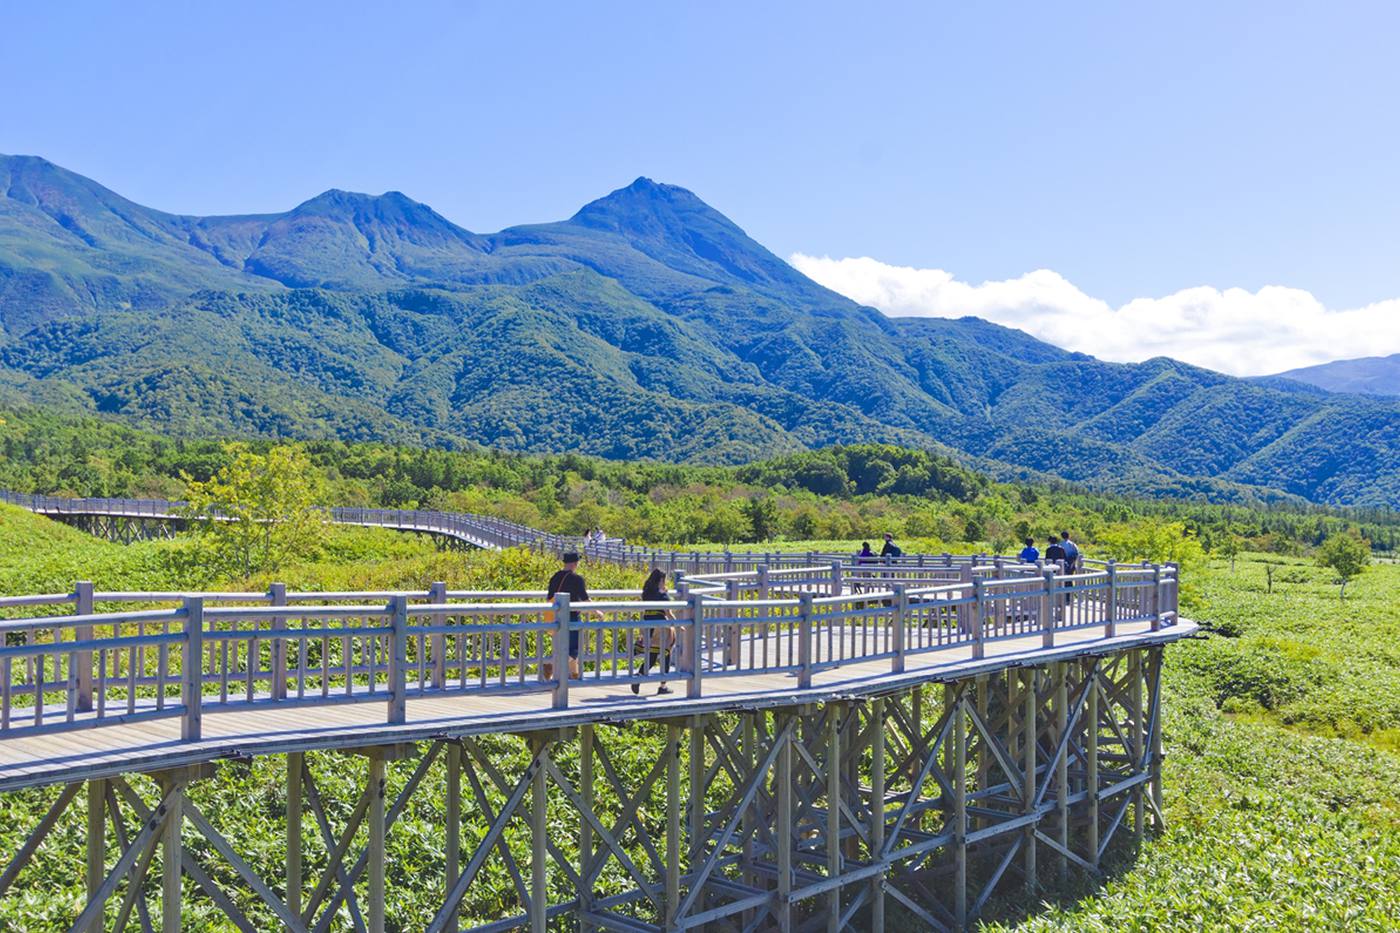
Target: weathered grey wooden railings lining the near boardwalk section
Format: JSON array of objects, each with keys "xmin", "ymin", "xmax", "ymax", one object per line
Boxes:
[{"xmin": 0, "ymin": 559, "xmax": 1177, "ymax": 741}]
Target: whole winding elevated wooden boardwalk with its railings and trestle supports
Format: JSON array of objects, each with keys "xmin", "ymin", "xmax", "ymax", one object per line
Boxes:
[{"xmin": 0, "ymin": 493, "xmax": 1196, "ymax": 930}]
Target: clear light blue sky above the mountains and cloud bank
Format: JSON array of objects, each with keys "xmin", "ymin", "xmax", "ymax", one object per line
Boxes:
[{"xmin": 0, "ymin": 0, "xmax": 1400, "ymax": 368}]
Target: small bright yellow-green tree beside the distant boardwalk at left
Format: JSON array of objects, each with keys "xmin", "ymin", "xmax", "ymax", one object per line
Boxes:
[{"xmin": 185, "ymin": 444, "xmax": 325, "ymax": 577}]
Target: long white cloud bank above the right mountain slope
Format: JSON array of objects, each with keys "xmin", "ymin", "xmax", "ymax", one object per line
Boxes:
[{"xmin": 791, "ymin": 254, "xmax": 1400, "ymax": 375}]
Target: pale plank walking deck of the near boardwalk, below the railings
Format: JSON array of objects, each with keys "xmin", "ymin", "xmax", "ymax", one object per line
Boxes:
[{"xmin": 0, "ymin": 619, "xmax": 1197, "ymax": 792}]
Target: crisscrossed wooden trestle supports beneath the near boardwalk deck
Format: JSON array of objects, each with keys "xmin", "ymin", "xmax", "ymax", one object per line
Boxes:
[{"xmin": 0, "ymin": 647, "xmax": 1162, "ymax": 933}]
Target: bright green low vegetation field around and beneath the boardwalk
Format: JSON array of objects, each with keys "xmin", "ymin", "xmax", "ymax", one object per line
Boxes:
[{"xmin": 0, "ymin": 509, "xmax": 1400, "ymax": 930}]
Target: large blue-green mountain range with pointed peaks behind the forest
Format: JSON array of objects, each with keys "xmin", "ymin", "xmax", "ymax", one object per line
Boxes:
[{"xmin": 0, "ymin": 157, "xmax": 1400, "ymax": 507}]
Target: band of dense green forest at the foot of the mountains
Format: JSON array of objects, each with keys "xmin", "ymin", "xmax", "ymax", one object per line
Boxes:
[{"xmin": 0, "ymin": 409, "xmax": 1400, "ymax": 553}]
